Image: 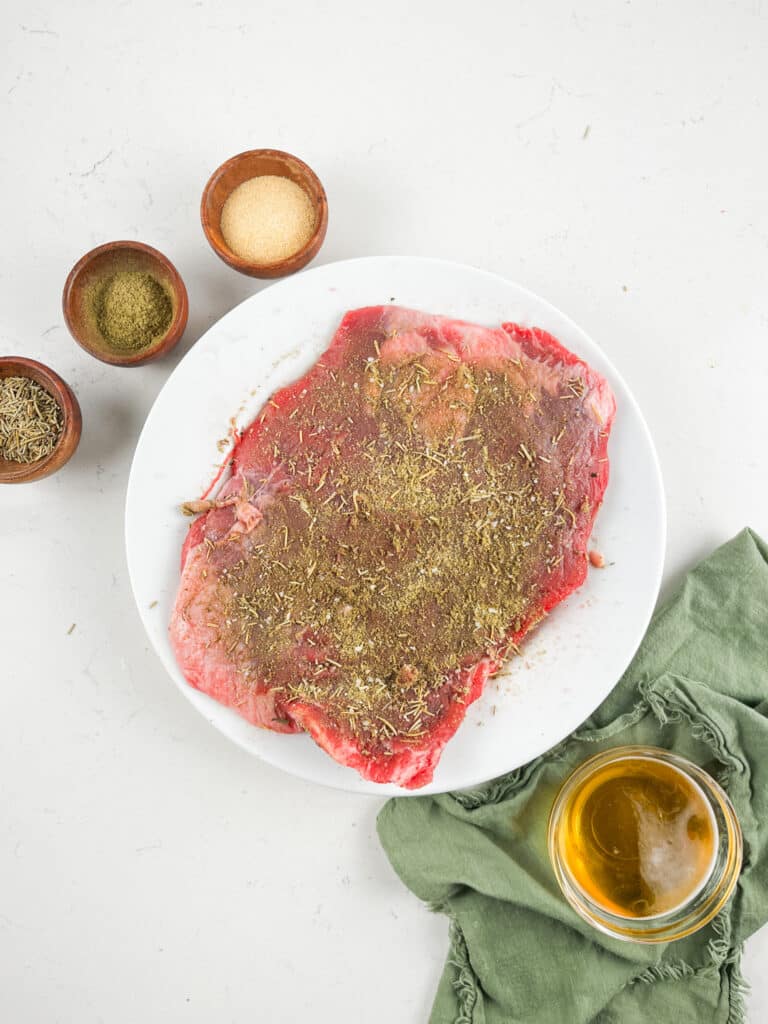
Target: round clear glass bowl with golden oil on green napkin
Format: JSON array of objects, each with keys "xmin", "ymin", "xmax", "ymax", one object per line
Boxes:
[{"xmin": 548, "ymin": 746, "xmax": 742, "ymax": 942}]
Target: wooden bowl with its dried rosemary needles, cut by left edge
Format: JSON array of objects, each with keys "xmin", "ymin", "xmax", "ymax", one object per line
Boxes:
[{"xmin": 0, "ymin": 355, "xmax": 83, "ymax": 483}]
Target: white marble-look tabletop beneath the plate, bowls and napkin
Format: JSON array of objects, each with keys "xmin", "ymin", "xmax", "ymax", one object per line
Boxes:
[{"xmin": 0, "ymin": 0, "xmax": 768, "ymax": 1024}]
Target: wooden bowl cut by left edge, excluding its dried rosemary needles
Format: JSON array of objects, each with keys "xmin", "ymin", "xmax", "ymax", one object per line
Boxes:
[{"xmin": 0, "ymin": 355, "xmax": 83, "ymax": 483}]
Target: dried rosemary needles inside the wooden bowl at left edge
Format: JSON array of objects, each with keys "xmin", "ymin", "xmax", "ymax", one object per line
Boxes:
[{"xmin": 0, "ymin": 377, "xmax": 63, "ymax": 463}]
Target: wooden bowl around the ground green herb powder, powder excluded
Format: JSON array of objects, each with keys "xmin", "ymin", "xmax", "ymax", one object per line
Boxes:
[{"xmin": 61, "ymin": 242, "xmax": 189, "ymax": 367}]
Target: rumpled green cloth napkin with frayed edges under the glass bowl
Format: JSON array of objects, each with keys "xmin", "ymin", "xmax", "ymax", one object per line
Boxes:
[{"xmin": 378, "ymin": 530, "xmax": 768, "ymax": 1024}]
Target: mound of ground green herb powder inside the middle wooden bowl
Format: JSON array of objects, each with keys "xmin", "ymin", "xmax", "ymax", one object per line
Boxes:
[{"xmin": 94, "ymin": 270, "xmax": 173, "ymax": 351}]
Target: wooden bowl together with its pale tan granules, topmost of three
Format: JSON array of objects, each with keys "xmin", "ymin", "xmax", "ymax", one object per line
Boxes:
[{"xmin": 200, "ymin": 150, "xmax": 328, "ymax": 278}]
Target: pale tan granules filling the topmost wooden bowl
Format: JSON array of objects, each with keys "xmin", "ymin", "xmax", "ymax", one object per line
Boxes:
[{"xmin": 221, "ymin": 174, "xmax": 315, "ymax": 263}]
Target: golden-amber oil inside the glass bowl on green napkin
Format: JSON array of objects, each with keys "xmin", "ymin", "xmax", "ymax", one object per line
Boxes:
[{"xmin": 556, "ymin": 757, "xmax": 718, "ymax": 919}]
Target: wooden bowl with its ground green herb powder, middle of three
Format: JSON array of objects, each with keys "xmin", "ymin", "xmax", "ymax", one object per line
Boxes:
[{"xmin": 61, "ymin": 242, "xmax": 188, "ymax": 367}]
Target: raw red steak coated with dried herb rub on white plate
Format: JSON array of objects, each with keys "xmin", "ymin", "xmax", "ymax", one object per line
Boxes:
[{"xmin": 171, "ymin": 306, "xmax": 615, "ymax": 787}]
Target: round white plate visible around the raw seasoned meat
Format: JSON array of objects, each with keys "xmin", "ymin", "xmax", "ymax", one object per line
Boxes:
[{"xmin": 126, "ymin": 257, "xmax": 665, "ymax": 795}]
